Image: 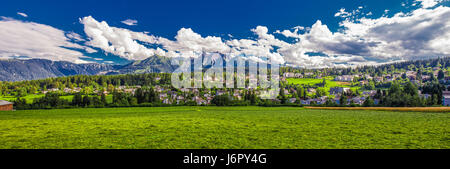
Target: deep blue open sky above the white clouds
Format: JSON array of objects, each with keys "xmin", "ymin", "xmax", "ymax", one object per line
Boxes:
[{"xmin": 0, "ymin": 0, "xmax": 403, "ymax": 38}]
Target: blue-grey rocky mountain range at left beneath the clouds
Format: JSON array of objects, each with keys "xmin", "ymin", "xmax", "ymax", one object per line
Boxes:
[{"xmin": 0, "ymin": 56, "xmax": 176, "ymax": 81}]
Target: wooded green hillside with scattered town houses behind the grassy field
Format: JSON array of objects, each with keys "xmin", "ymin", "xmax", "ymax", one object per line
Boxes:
[{"xmin": 0, "ymin": 58, "xmax": 450, "ymax": 109}]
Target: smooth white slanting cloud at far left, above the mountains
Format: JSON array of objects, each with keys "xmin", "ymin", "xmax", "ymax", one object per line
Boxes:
[{"xmin": 0, "ymin": 17, "xmax": 90, "ymax": 63}]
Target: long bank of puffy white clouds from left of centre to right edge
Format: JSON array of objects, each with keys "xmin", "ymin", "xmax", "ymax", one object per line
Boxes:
[{"xmin": 80, "ymin": 0, "xmax": 450, "ymax": 68}]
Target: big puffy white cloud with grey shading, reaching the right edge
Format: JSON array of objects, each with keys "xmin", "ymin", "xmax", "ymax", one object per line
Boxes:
[{"xmin": 279, "ymin": 2, "xmax": 450, "ymax": 67}]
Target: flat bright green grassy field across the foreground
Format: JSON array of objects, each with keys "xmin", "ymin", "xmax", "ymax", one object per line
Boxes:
[{"xmin": 0, "ymin": 107, "xmax": 450, "ymax": 149}]
